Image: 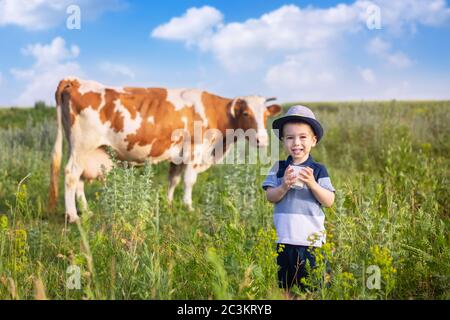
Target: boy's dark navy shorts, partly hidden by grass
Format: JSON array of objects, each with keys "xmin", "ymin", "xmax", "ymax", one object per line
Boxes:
[{"xmin": 277, "ymin": 243, "xmax": 316, "ymax": 289}]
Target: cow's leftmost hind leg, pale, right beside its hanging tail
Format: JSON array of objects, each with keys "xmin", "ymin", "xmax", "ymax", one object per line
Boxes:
[{"xmin": 64, "ymin": 154, "xmax": 83, "ymax": 223}]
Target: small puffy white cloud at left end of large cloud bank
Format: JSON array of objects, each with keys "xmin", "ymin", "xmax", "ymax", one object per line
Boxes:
[{"xmin": 151, "ymin": 6, "xmax": 223, "ymax": 43}]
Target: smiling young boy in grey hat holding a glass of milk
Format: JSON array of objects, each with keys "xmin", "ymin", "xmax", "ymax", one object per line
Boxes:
[{"xmin": 262, "ymin": 106, "xmax": 335, "ymax": 290}]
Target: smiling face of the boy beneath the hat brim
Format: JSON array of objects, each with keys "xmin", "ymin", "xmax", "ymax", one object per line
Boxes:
[{"xmin": 283, "ymin": 123, "xmax": 317, "ymax": 163}]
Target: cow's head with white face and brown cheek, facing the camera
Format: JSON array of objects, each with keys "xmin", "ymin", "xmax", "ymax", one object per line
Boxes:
[{"xmin": 230, "ymin": 96, "xmax": 281, "ymax": 147}]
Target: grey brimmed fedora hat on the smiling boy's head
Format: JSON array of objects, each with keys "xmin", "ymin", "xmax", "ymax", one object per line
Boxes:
[{"xmin": 272, "ymin": 105, "xmax": 323, "ymax": 142}]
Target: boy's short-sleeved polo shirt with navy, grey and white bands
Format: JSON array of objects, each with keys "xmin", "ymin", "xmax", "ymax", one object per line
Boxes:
[{"xmin": 262, "ymin": 155, "xmax": 335, "ymax": 247}]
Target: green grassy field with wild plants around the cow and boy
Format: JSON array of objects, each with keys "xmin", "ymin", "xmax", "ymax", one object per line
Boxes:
[{"xmin": 0, "ymin": 101, "xmax": 450, "ymax": 299}]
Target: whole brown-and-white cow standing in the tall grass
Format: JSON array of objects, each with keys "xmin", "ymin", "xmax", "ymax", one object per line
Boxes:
[{"xmin": 49, "ymin": 78, "xmax": 281, "ymax": 222}]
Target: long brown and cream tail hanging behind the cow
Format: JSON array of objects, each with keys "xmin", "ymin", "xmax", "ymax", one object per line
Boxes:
[{"xmin": 48, "ymin": 80, "xmax": 67, "ymax": 212}]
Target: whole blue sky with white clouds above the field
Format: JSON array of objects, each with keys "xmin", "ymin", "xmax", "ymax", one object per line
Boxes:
[{"xmin": 0, "ymin": 0, "xmax": 450, "ymax": 106}]
